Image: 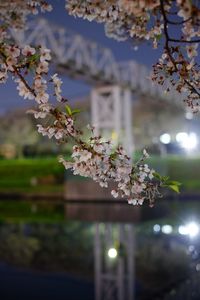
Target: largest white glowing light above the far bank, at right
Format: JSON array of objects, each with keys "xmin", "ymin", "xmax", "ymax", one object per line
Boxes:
[{"xmin": 176, "ymin": 132, "xmax": 198, "ymax": 150}]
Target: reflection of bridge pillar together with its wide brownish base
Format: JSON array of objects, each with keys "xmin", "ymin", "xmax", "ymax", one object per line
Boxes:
[{"xmin": 65, "ymin": 199, "xmax": 168, "ymax": 300}]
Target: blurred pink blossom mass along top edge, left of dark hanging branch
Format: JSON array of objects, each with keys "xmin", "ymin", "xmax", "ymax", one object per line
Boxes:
[{"xmin": 66, "ymin": 0, "xmax": 163, "ymax": 44}]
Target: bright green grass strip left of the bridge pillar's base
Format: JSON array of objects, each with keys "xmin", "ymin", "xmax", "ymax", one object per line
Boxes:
[{"xmin": 0, "ymin": 158, "xmax": 64, "ymax": 192}]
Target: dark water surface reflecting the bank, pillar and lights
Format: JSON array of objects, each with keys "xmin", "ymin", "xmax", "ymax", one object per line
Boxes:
[{"xmin": 0, "ymin": 200, "xmax": 200, "ymax": 300}]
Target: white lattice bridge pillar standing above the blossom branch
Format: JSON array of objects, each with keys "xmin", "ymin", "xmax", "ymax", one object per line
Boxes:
[{"xmin": 91, "ymin": 85, "xmax": 134, "ymax": 156}]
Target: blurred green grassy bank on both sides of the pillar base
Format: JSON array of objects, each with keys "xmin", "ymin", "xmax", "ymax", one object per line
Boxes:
[{"xmin": 0, "ymin": 156, "xmax": 200, "ymax": 193}]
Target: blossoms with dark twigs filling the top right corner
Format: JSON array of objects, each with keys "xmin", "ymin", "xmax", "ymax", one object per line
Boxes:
[{"xmin": 66, "ymin": 0, "xmax": 200, "ymax": 112}]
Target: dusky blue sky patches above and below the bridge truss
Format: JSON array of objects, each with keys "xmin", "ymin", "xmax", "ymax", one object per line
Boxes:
[{"xmin": 0, "ymin": 0, "xmax": 160, "ymax": 113}]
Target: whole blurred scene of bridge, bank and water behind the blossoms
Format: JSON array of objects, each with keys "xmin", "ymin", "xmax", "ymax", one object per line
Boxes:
[{"xmin": 0, "ymin": 0, "xmax": 200, "ymax": 300}]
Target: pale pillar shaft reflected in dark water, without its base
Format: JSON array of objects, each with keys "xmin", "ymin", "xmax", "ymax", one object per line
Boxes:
[{"xmin": 94, "ymin": 223, "xmax": 135, "ymax": 300}]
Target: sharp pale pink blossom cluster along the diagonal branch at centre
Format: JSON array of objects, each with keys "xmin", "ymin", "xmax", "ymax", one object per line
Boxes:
[{"xmin": 4, "ymin": 39, "xmax": 164, "ymax": 205}]
